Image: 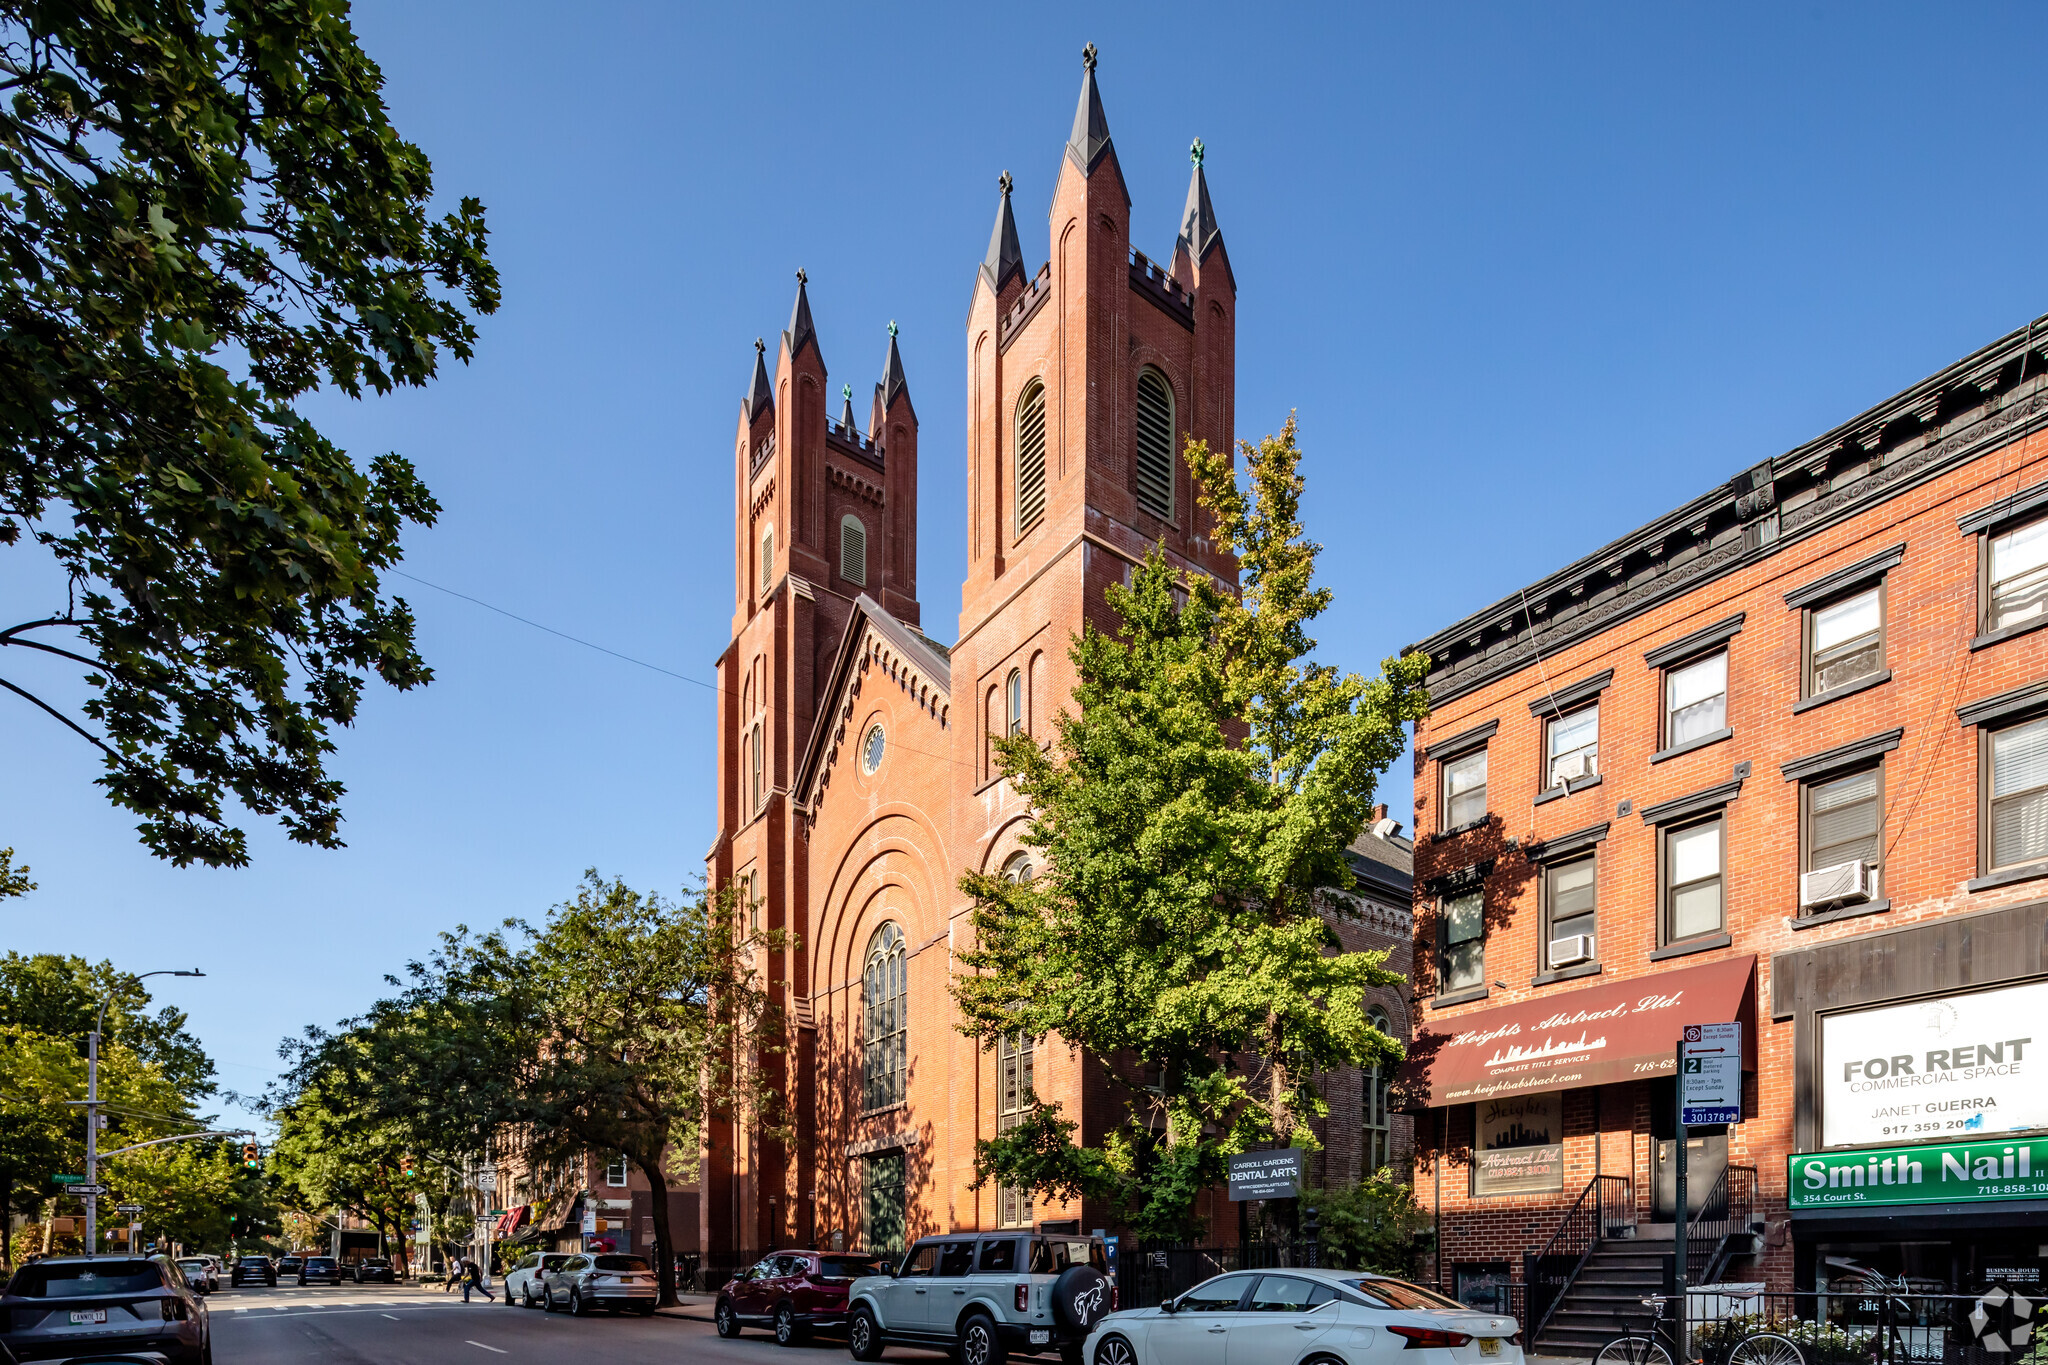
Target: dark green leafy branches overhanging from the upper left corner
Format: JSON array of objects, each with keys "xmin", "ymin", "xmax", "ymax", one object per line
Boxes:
[{"xmin": 0, "ymin": 0, "xmax": 498, "ymax": 866}]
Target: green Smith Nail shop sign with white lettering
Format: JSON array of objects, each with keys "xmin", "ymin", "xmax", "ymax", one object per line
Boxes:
[{"xmin": 1786, "ymin": 1138, "xmax": 2048, "ymax": 1209}]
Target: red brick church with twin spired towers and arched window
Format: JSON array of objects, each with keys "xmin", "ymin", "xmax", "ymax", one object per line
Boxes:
[{"xmin": 700, "ymin": 47, "xmax": 1405, "ymax": 1267}]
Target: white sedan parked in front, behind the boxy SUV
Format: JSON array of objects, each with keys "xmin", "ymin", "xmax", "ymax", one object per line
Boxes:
[{"xmin": 1081, "ymin": 1271, "xmax": 1522, "ymax": 1365}]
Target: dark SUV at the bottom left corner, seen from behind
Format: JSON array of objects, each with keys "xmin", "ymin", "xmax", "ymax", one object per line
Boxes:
[{"xmin": 0, "ymin": 1257, "xmax": 213, "ymax": 1365}]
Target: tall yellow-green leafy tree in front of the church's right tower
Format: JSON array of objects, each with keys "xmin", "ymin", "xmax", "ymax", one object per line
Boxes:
[{"xmin": 952, "ymin": 417, "xmax": 1425, "ymax": 1238}]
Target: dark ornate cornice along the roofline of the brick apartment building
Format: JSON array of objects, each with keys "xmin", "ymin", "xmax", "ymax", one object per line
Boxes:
[{"xmin": 1413, "ymin": 319, "xmax": 2048, "ymax": 706}]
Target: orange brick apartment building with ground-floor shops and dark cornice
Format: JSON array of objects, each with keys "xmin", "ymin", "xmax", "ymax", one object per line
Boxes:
[{"xmin": 1403, "ymin": 309, "xmax": 2048, "ymax": 1351}]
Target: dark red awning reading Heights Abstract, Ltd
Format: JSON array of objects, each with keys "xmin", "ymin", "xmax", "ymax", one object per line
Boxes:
[{"xmin": 1397, "ymin": 956, "xmax": 1757, "ymax": 1109}]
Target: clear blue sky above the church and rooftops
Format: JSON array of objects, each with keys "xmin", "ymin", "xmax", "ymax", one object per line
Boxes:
[{"xmin": 0, "ymin": 0, "xmax": 2048, "ymax": 1129}]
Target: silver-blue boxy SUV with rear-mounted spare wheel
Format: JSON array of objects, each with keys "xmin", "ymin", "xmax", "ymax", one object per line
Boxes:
[{"xmin": 846, "ymin": 1232, "xmax": 1116, "ymax": 1365}]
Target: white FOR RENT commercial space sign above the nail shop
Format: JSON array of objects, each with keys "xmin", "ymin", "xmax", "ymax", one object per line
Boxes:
[{"xmin": 1821, "ymin": 980, "xmax": 2048, "ymax": 1146}]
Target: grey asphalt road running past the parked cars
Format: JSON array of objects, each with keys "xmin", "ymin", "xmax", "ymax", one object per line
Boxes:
[{"xmin": 209, "ymin": 1285, "xmax": 944, "ymax": 1365}]
